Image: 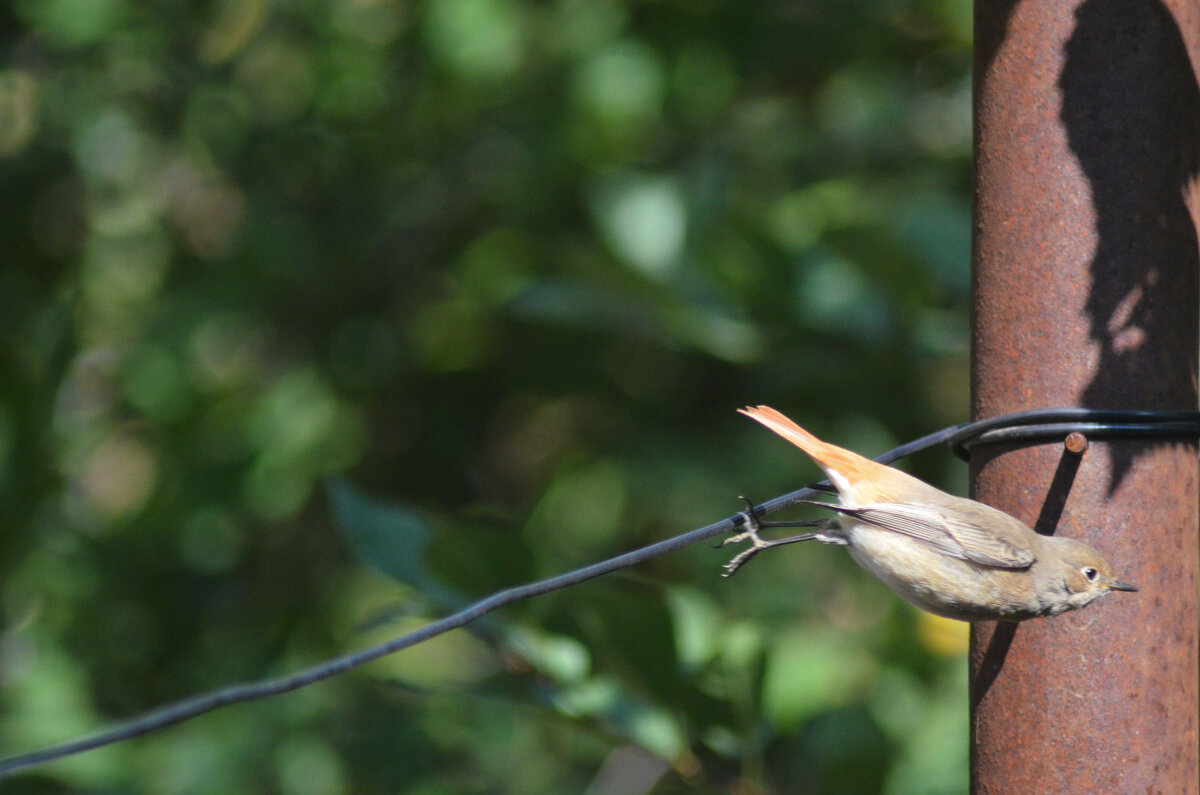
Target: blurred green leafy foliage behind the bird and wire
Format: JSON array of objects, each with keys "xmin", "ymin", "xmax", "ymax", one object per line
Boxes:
[{"xmin": 0, "ymin": 0, "xmax": 971, "ymax": 795}]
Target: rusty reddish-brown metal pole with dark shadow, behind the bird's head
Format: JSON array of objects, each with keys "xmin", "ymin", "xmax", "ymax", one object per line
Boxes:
[{"xmin": 971, "ymin": 0, "xmax": 1200, "ymax": 795}]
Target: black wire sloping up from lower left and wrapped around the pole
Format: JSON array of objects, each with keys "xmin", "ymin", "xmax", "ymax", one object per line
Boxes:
[{"xmin": 0, "ymin": 408, "xmax": 1200, "ymax": 778}]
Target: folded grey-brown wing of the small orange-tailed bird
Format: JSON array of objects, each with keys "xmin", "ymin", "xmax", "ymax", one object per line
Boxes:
[{"xmin": 839, "ymin": 498, "xmax": 1036, "ymax": 569}]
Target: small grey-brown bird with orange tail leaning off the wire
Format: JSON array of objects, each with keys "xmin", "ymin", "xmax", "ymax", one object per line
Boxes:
[{"xmin": 725, "ymin": 406, "xmax": 1138, "ymax": 621}]
